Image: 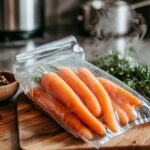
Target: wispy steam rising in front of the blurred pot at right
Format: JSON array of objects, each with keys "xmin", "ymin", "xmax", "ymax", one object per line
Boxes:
[{"xmin": 88, "ymin": 1, "xmax": 147, "ymax": 57}]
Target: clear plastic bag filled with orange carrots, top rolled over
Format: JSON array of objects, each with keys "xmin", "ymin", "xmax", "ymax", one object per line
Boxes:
[{"xmin": 14, "ymin": 36, "xmax": 150, "ymax": 148}]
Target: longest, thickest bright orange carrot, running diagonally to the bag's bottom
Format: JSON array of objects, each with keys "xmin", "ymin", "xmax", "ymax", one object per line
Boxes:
[{"xmin": 41, "ymin": 72, "xmax": 106, "ymax": 135}]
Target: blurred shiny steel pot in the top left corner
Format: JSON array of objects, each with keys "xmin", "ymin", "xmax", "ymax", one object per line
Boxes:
[{"xmin": 0, "ymin": 0, "xmax": 44, "ymax": 38}]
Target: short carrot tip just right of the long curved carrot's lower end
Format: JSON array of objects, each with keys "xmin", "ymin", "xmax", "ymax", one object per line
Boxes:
[{"xmin": 112, "ymin": 101, "xmax": 129, "ymax": 125}]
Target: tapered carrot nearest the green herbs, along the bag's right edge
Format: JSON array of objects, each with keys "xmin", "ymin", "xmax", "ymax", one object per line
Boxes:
[{"xmin": 98, "ymin": 77, "xmax": 141, "ymax": 106}]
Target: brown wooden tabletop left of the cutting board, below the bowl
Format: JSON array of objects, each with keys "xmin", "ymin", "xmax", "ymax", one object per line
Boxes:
[{"xmin": 0, "ymin": 101, "xmax": 18, "ymax": 150}]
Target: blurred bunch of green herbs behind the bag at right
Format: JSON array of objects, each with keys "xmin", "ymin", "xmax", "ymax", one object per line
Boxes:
[{"xmin": 91, "ymin": 51, "xmax": 150, "ymax": 101}]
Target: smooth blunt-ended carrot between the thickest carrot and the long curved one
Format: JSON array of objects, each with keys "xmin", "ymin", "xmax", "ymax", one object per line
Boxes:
[{"xmin": 58, "ymin": 67, "xmax": 101, "ymax": 117}]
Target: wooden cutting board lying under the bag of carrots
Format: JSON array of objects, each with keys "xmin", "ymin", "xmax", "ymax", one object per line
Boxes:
[{"xmin": 17, "ymin": 93, "xmax": 150, "ymax": 150}]
